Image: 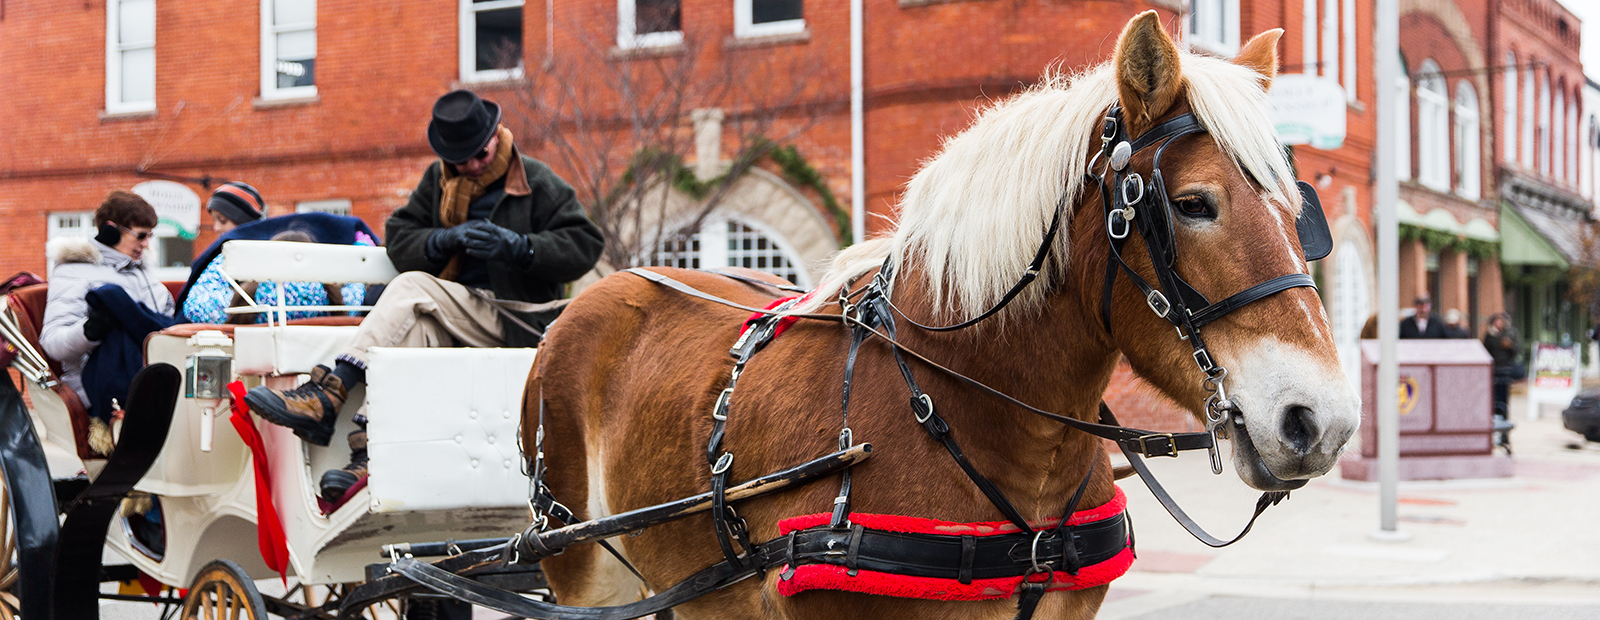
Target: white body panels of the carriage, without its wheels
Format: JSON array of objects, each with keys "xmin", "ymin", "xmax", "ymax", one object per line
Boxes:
[{"xmin": 46, "ymin": 241, "xmax": 536, "ymax": 586}]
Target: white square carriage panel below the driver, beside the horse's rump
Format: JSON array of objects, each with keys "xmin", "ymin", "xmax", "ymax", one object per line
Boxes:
[{"xmin": 366, "ymin": 347, "xmax": 538, "ymax": 513}]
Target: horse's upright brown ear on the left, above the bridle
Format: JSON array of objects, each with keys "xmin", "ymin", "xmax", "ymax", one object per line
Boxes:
[{"xmin": 1114, "ymin": 11, "xmax": 1182, "ymax": 136}]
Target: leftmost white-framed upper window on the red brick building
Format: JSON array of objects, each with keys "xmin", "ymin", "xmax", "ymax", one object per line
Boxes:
[{"xmin": 106, "ymin": 0, "xmax": 155, "ymax": 113}]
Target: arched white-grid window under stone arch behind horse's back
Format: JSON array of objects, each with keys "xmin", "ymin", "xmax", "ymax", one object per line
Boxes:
[{"xmin": 645, "ymin": 214, "xmax": 811, "ymax": 286}]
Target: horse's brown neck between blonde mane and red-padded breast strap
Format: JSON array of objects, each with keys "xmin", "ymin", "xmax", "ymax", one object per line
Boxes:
[{"xmin": 894, "ymin": 225, "xmax": 1117, "ymax": 518}]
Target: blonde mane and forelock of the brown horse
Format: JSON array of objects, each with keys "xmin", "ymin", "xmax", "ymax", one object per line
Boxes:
[{"xmin": 794, "ymin": 54, "xmax": 1299, "ymax": 321}]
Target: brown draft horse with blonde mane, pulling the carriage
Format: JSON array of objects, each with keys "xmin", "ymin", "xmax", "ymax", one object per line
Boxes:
[{"xmin": 523, "ymin": 11, "xmax": 1358, "ymax": 620}]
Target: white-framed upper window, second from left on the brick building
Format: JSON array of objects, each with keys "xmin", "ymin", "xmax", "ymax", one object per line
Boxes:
[{"xmin": 261, "ymin": 0, "xmax": 317, "ymax": 99}]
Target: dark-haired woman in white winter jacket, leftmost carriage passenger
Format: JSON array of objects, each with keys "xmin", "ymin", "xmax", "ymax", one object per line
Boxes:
[{"xmin": 38, "ymin": 190, "xmax": 173, "ymax": 454}]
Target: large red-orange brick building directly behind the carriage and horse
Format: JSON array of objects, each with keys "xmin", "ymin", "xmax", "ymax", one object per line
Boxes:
[{"xmin": 0, "ymin": 0, "xmax": 1401, "ymax": 423}]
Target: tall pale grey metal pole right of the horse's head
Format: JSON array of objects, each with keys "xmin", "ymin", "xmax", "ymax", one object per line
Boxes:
[{"xmin": 1373, "ymin": 0, "xmax": 1408, "ymax": 540}]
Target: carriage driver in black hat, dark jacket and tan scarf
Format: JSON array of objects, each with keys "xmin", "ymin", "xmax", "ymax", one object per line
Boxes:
[{"xmin": 245, "ymin": 91, "xmax": 605, "ymax": 502}]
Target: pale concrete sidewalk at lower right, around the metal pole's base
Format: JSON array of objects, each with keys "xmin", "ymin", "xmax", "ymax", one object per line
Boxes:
[{"xmin": 1101, "ymin": 398, "xmax": 1600, "ymax": 620}]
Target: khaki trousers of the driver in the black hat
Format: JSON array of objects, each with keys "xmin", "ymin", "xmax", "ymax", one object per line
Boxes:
[{"xmin": 339, "ymin": 272, "xmax": 505, "ymax": 368}]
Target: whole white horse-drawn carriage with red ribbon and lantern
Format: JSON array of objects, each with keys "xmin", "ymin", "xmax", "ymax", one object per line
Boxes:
[{"xmin": 0, "ymin": 241, "xmax": 541, "ymax": 618}]
